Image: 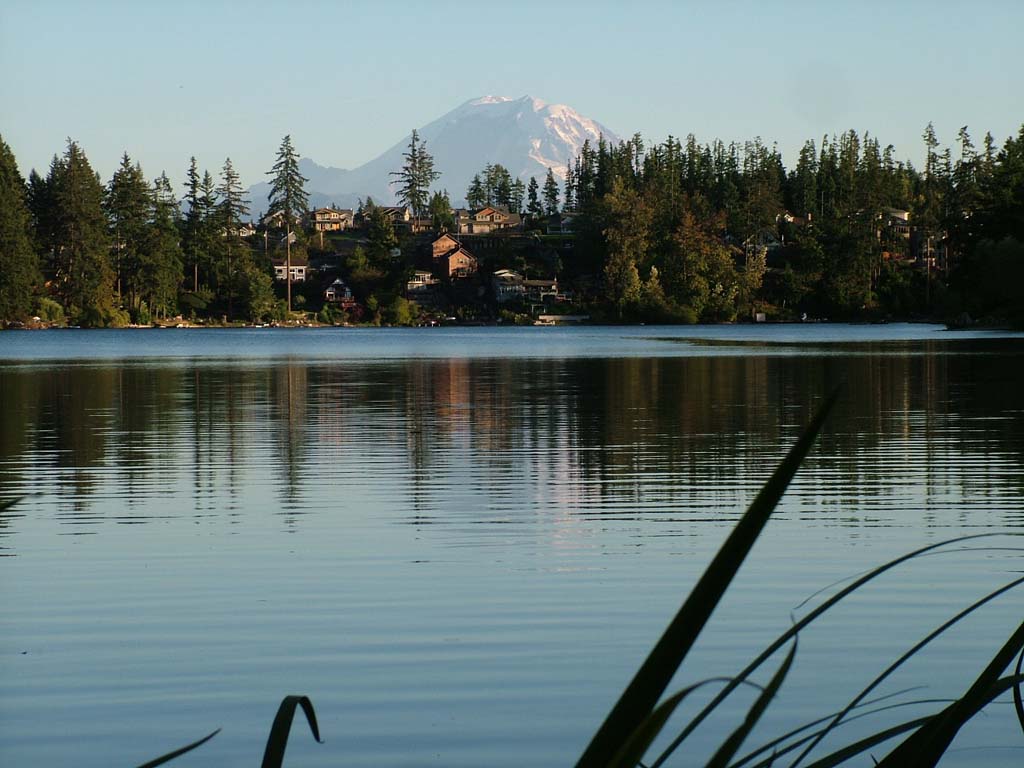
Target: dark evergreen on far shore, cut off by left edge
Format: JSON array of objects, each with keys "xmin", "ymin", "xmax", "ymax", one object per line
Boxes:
[{"xmin": 0, "ymin": 136, "xmax": 42, "ymax": 324}]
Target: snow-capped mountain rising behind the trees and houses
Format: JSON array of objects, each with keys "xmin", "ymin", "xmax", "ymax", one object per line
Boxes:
[{"xmin": 249, "ymin": 96, "xmax": 618, "ymax": 217}]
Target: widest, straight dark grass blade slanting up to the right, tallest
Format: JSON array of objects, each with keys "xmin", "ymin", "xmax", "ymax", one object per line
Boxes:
[{"xmin": 577, "ymin": 391, "xmax": 838, "ymax": 768}]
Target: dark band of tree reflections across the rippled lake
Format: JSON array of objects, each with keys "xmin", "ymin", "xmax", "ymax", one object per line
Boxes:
[{"xmin": 0, "ymin": 345, "xmax": 1024, "ymax": 536}]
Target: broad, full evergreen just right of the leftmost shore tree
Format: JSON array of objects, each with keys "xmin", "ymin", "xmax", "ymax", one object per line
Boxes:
[{"xmin": 47, "ymin": 139, "xmax": 119, "ymax": 326}]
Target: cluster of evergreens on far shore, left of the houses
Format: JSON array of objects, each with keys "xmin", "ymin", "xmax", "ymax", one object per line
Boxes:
[{"xmin": 0, "ymin": 136, "xmax": 307, "ymax": 328}]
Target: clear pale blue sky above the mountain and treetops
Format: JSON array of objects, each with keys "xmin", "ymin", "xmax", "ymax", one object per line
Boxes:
[{"xmin": 0, "ymin": 0, "xmax": 1024, "ymax": 192}]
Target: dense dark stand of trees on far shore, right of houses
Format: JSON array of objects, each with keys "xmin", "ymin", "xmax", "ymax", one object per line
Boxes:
[{"xmin": 562, "ymin": 124, "xmax": 1024, "ymax": 323}]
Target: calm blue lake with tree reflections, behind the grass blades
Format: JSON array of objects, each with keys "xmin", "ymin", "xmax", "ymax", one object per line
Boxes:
[{"xmin": 0, "ymin": 324, "xmax": 1024, "ymax": 767}]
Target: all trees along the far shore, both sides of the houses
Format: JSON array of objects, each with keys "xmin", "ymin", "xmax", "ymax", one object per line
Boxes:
[{"xmin": 0, "ymin": 120, "xmax": 1024, "ymax": 327}]
